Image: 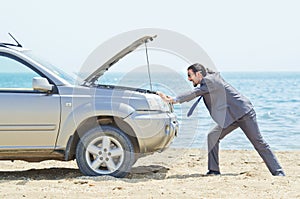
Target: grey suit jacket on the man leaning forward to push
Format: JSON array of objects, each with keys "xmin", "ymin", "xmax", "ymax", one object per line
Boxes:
[{"xmin": 176, "ymin": 73, "xmax": 253, "ymax": 128}]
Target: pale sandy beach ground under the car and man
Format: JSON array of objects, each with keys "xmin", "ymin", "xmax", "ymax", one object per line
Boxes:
[{"xmin": 0, "ymin": 148, "xmax": 300, "ymax": 198}]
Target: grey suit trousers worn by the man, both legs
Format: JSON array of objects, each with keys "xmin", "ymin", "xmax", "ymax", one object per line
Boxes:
[{"xmin": 207, "ymin": 109, "xmax": 282, "ymax": 175}]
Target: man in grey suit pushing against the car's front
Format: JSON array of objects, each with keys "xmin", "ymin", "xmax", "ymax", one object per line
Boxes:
[{"xmin": 157, "ymin": 63, "xmax": 285, "ymax": 176}]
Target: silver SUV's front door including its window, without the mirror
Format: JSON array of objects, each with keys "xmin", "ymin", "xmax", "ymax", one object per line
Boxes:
[{"xmin": 0, "ymin": 54, "xmax": 60, "ymax": 149}]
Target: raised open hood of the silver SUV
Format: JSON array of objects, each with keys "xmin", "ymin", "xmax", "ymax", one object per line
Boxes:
[{"xmin": 83, "ymin": 35, "xmax": 156, "ymax": 86}]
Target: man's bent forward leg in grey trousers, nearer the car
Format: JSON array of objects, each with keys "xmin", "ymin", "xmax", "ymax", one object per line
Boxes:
[{"xmin": 207, "ymin": 123, "xmax": 238, "ymax": 171}]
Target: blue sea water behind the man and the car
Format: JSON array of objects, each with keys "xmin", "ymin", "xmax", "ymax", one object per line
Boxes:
[{"xmin": 0, "ymin": 72, "xmax": 300, "ymax": 151}]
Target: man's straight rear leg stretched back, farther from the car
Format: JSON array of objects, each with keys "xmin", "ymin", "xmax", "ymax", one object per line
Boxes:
[{"xmin": 237, "ymin": 110, "xmax": 282, "ymax": 175}]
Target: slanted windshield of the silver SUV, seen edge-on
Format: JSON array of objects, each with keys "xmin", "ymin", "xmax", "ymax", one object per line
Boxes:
[{"xmin": 23, "ymin": 51, "xmax": 76, "ymax": 84}]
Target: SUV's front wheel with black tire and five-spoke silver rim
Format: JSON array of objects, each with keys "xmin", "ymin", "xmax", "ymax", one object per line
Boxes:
[{"xmin": 76, "ymin": 126, "xmax": 135, "ymax": 177}]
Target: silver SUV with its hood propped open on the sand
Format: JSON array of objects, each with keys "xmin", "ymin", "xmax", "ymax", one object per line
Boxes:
[{"xmin": 0, "ymin": 36, "xmax": 178, "ymax": 177}]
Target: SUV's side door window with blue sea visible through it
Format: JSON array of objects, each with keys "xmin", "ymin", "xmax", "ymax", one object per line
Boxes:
[{"xmin": 0, "ymin": 55, "xmax": 40, "ymax": 92}]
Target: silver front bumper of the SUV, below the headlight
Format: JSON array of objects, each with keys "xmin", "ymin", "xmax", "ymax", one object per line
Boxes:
[{"xmin": 125, "ymin": 111, "xmax": 179, "ymax": 153}]
